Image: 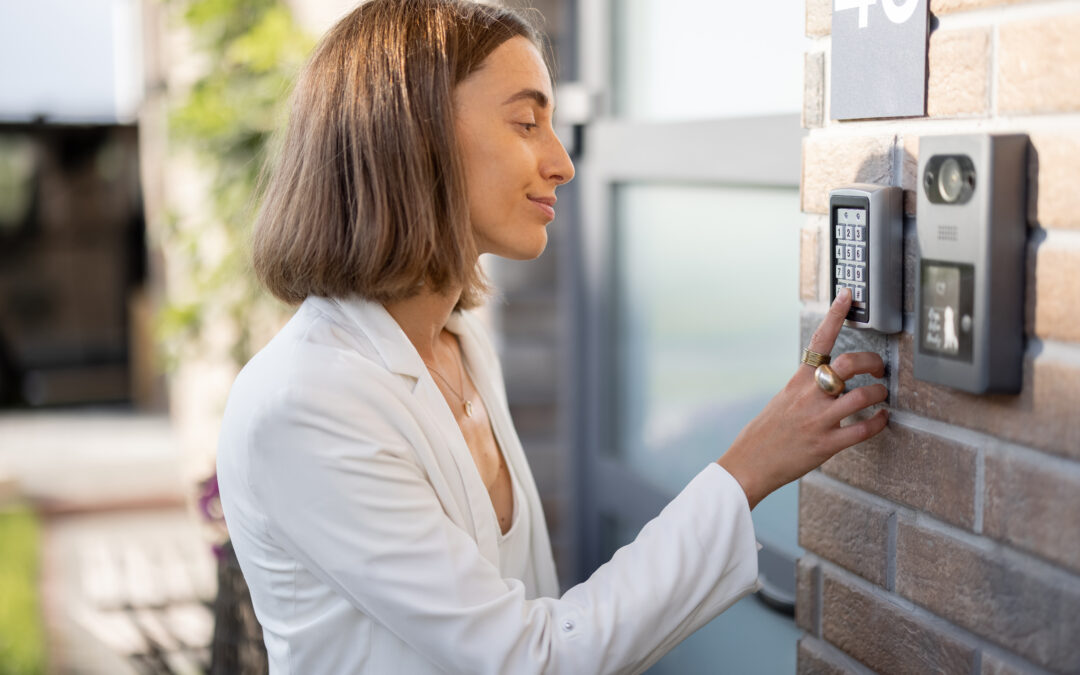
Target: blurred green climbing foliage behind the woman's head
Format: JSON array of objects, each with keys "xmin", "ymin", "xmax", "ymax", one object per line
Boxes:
[{"xmin": 159, "ymin": 0, "xmax": 314, "ymax": 365}]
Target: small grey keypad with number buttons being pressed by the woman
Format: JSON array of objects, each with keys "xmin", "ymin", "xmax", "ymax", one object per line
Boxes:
[{"xmin": 828, "ymin": 184, "xmax": 904, "ymax": 333}]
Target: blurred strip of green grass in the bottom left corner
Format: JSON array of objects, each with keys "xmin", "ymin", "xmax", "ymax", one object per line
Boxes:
[{"xmin": 0, "ymin": 509, "xmax": 45, "ymax": 675}]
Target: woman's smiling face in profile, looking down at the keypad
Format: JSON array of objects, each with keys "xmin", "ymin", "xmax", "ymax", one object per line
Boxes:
[{"xmin": 455, "ymin": 37, "xmax": 573, "ymax": 260}]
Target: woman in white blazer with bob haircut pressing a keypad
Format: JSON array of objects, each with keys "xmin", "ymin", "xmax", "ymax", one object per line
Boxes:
[{"xmin": 218, "ymin": 0, "xmax": 887, "ymax": 674}]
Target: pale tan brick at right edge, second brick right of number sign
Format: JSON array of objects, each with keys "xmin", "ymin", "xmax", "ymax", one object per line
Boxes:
[{"xmin": 998, "ymin": 14, "xmax": 1080, "ymax": 113}]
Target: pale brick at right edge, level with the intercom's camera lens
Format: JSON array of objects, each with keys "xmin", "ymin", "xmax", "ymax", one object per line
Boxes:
[{"xmin": 1027, "ymin": 133, "xmax": 1080, "ymax": 229}]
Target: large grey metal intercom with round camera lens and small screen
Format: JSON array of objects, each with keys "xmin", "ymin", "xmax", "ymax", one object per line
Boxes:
[{"xmin": 915, "ymin": 134, "xmax": 1028, "ymax": 393}]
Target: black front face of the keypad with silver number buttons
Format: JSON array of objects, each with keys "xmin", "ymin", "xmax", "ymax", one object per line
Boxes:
[{"xmin": 829, "ymin": 206, "xmax": 869, "ymax": 322}]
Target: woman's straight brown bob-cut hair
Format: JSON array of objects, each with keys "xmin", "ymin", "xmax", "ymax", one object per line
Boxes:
[{"xmin": 253, "ymin": 0, "xmax": 544, "ymax": 309}]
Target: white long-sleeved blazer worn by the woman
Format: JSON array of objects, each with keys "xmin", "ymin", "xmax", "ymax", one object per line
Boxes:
[{"xmin": 217, "ymin": 297, "xmax": 757, "ymax": 675}]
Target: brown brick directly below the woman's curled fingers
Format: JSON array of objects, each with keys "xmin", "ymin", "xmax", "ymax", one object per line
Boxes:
[{"xmin": 822, "ymin": 421, "xmax": 976, "ymax": 529}]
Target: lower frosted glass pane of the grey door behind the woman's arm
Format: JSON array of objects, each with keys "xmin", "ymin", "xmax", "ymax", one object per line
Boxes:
[{"xmin": 616, "ymin": 185, "xmax": 802, "ymax": 520}]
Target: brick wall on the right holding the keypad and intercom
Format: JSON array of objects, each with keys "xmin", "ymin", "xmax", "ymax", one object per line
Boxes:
[{"xmin": 796, "ymin": 0, "xmax": 1080, "ymax": 674}]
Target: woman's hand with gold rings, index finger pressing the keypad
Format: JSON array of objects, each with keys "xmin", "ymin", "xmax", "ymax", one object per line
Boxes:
[{"xmin": 717, "ymin": 291, "xmax": 889, "ymax": 509}]
